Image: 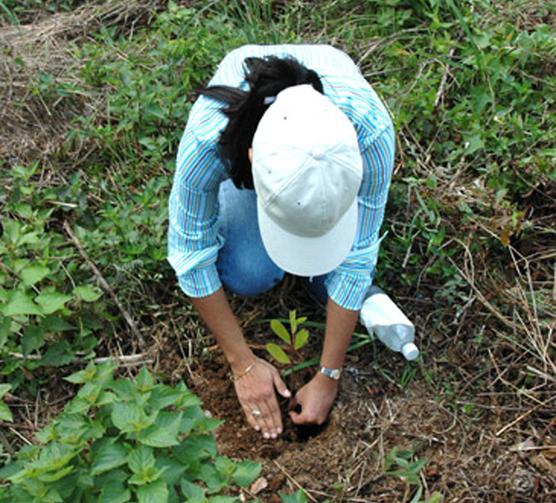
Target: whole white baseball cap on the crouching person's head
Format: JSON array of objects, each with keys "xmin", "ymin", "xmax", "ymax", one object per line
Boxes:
[{"xmin": 252, "ymin": 85, "xmax": 363, "ymax": 276}]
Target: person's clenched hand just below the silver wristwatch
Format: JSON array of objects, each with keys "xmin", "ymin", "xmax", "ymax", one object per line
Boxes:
[{"xmin": 290, "ymin": 372, "xmax": 338, "ymax": 425}]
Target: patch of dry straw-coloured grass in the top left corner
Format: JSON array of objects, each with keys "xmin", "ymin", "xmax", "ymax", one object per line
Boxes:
[{"xmin": 0, "ymin": 0, "xmax": 163, "ymax": 165}]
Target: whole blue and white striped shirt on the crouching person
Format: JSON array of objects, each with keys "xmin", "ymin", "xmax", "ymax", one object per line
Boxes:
[{"xmin": 168, "ymin": 45, "xmax": 395, "ymax": 310}]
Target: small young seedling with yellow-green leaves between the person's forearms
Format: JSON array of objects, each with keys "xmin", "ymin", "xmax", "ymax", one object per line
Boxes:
[{"xmin": 266, "ymin": 310, "xmax": 309, "ymax": 365}]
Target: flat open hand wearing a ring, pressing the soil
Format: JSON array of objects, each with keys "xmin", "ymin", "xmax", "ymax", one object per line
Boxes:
[{"xmin": 234, "ymin": 358, "xmax": 291, "ymax": 438}]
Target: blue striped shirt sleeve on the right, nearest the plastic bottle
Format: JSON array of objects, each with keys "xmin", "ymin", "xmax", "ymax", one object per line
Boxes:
[{"xmin": 325, "ymin": 125, "xmax": 395, "ymax": 311}]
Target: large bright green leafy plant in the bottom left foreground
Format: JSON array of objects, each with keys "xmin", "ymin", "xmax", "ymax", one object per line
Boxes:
[{"xmin": 0, "ymin": 362, "xmax": 260, "ymax": 503}]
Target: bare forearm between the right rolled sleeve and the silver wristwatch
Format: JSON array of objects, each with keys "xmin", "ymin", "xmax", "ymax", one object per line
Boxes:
[{"xmin": 320, "ymin": 298, "xmax": 359, "ymax": 368}]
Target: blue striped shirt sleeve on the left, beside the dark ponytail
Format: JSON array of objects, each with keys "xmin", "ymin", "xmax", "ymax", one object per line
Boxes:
[{"xmin": 168, "ymin": 129, "xmax": 224, "ymax": 297}]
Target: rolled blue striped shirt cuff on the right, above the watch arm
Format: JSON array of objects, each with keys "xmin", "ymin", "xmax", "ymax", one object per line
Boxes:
[{"xmin": 324, "ymin": 270, "xmax": 374, "ymax": 311}]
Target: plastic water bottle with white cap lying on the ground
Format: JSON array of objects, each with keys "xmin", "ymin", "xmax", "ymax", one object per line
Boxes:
[{"xmin": 360, "ymin": 286, "xmax": 419, "ymax": 360}]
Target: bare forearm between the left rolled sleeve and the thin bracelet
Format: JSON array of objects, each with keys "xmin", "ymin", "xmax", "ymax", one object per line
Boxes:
[{"xmin": 191, "ymin": 288, "xmax": 255, "ymax": 373}]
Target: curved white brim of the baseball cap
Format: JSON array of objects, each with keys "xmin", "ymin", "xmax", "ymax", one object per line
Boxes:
[{"xmin": 257, "ymin": 198, "xmax": 357, "ymax": 276}]
